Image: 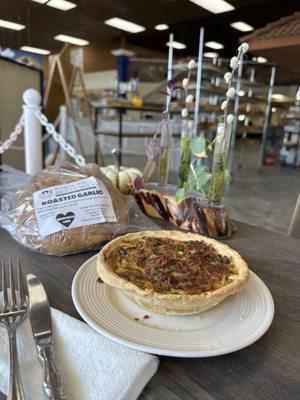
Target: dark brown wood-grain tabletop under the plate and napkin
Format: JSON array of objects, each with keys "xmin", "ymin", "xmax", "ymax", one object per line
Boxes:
[{"xmin": 0, "ymin": 223, "xmax": 300, "ymax": 400}]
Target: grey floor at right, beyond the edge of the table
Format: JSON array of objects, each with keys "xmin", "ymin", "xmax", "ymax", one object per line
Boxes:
[{"xmin": 224, "ymin": 145, "xmax": 300, "ymax": 234}]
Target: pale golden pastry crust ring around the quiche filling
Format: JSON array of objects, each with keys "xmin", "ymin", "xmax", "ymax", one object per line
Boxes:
[{"xmin": 97, "ymin": 230, "xmax": 249, "ymax": 315}]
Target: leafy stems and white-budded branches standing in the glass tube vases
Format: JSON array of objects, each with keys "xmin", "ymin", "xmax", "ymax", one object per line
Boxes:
[{"xmin": 135, "ymin": 43, "xmax": 249, "ymax": 211}]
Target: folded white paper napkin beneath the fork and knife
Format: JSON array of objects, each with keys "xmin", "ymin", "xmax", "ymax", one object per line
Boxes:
[{"xmin": 0, "ymin": 309, "xmax": 158, "ymax": 400}]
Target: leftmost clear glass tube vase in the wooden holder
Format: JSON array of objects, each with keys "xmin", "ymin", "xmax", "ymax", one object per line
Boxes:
[{"xmin": 157, "ymin": 120, "xmax": 173, "ymax": 186}]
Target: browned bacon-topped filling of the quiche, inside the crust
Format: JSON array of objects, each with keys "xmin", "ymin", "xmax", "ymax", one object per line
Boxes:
[{"xmin": 107, "ymin": 237, "xmax": 236, "ymax": 294}]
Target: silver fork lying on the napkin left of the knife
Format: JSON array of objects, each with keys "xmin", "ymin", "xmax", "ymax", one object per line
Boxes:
[{"xmin": 0, "ymin": 258, "xmax": 27, "ymax": 400}]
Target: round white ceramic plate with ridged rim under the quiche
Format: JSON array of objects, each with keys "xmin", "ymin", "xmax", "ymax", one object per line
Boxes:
[{"xmin": 72, "ymin": 256, "xmax": 274, "ymax": 357}]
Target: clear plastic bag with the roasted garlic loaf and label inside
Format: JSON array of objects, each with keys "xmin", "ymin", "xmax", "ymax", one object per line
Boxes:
[{"xmin": 0, "ymin": 162, "xmax": 159, "ymax": 256}]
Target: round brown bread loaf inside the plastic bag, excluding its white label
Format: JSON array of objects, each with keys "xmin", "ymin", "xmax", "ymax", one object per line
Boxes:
[{"xmin": 10, "ymin": 163, "xmax": 131, "ymax": 255}]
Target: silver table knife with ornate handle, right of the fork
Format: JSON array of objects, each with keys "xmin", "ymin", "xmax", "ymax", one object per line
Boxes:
[{"xmin": 26, "ymin": 274, "xmax": 67, "ymax": 400}]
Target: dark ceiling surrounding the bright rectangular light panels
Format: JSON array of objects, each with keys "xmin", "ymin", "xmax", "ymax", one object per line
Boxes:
[{"xmin": 0, "ymin": 0, "xmax": 299, "ymax": 56}]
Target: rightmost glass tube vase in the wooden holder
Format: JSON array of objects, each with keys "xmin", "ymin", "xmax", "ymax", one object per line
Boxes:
[{"xmin": 208, "ymin": 123, "xmax": 232, "ymax": 206}]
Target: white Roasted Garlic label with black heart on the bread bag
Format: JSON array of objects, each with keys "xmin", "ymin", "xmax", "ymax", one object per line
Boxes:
[{"xmin": 33, "ymin": 177, "xmax": 117, "ymax": 236}]
